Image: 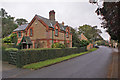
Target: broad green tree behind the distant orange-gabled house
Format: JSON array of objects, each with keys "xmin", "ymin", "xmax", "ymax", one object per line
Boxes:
[{"xmin": 78, "ymin": 25, "xmax": 103, "ymax": 42}]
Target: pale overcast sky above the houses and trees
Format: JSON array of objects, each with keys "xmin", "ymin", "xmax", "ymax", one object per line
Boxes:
[{"xmin": 0, "ymin": 0, "xmax": 109, "ymax": 40}]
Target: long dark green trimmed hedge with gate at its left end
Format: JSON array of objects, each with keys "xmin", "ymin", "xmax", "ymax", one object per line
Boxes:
[{"xmin": 2, "ymin": 47, "xmax": 87, "ymax": 67}]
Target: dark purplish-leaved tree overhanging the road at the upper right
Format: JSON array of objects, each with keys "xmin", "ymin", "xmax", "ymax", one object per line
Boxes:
[{"xmin": 90, "ymin": 0, "xmax": 120, "ymax": 51}]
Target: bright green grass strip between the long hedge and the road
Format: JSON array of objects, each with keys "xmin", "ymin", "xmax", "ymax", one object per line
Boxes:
[{"xmin": 23, "ymin": 48, "xmax": 97, "ymax": 70}]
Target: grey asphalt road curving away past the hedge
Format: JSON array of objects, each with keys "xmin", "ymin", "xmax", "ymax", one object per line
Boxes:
[{"xmin": 3, "ymin": 46, "xmax": 112, "ymax": 78}]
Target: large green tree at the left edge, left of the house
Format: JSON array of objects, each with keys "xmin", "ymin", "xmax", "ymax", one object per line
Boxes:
[{"xmin": 1, "ymin": 8, "xmax": 17, "ymax": 38}]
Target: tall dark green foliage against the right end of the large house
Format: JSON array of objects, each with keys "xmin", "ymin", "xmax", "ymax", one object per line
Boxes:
[{"xmin": 71, "ymin": 28, "xmax": 80, "ymax": 47}]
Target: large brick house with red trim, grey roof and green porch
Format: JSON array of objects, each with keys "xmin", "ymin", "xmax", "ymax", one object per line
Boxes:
[{"xmin": 13, "ymin": 10, "xmax": 72, "ymax": 49}]
